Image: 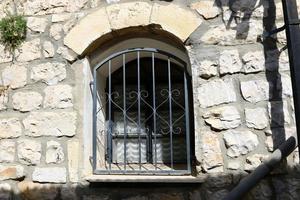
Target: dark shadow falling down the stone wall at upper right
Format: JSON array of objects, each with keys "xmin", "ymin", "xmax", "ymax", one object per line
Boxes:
[{"xmin": 214, "ymin": 0, "xmax": 293, "ymax": 158}]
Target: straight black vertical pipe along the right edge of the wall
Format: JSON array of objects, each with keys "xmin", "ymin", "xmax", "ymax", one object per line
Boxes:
[{"xmin": 282, "ymin": 0, "xmax": 300, "ymax": 158}]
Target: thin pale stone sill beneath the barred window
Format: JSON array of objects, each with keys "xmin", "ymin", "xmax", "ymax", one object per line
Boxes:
[{"xmin": 85, "ymin": 175, "xmax": 206, "ymax": 183}]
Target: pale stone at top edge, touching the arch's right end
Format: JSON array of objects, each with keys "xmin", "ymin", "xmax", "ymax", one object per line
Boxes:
[{"xmin": 191, "ymin": 1, "xmax": 221, "ymax": 19}]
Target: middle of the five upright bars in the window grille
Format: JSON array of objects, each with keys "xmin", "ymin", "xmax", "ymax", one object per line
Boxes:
[{"xmin": 137, "ymin": 51, "xmax": 142, "ymax": 170}]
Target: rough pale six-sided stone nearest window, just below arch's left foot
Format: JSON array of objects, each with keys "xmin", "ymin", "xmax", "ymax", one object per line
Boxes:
[{"xmin": 31, "ymin": 62, "xmax": 66, "ymax": 85}]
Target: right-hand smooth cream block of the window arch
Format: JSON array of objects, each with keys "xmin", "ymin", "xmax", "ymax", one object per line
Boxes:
[{"xmin": 150, "ymin": 3, "xmax": 202, "ymax": 41}]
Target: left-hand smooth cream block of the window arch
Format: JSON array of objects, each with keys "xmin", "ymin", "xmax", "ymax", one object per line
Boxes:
[{"xmin": 64, "ymin": 9, "xmax": 111, "ymax": 54}]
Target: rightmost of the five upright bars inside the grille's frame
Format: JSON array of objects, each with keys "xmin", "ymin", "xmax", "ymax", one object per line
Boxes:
[{"xmin": 168, "ymin": 57, "xmax": 173, "ymax": 169}]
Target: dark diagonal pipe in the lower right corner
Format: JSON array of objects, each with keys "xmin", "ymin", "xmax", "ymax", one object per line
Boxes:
[{"xmin": 223, "ymin": 136, "xmax": 297, "ymax": 200}]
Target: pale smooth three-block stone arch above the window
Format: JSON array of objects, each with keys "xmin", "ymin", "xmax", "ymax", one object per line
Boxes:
[{"xmin": 64, "ymin": 1, "xmax": 201, "ymax": 55}]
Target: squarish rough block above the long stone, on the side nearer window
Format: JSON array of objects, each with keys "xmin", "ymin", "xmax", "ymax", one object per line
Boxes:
[{"xmin": 44, "ymin": 85, "xmax": 73, "ymax": 108}]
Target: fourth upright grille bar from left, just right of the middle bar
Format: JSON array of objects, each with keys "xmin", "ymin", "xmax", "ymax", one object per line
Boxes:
[{"xmin": 151, "ymin": 53, "xmax": 157, "ymax": 170}]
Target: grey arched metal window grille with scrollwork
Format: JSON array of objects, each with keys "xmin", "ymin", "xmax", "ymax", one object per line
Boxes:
[{"xmin": 91, "ymin": 48, "xmax": 191, "ymax": 175}]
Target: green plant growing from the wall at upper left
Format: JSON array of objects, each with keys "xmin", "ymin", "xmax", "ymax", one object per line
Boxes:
[{"xmin": 0, "ymin": 15, "xmax": 26, "ymax": 53}]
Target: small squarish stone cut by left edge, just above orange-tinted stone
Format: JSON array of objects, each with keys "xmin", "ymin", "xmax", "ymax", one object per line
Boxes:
[{"xmin": 0, "ymin": 140, "xmax": 15, "ymax": 163}]
